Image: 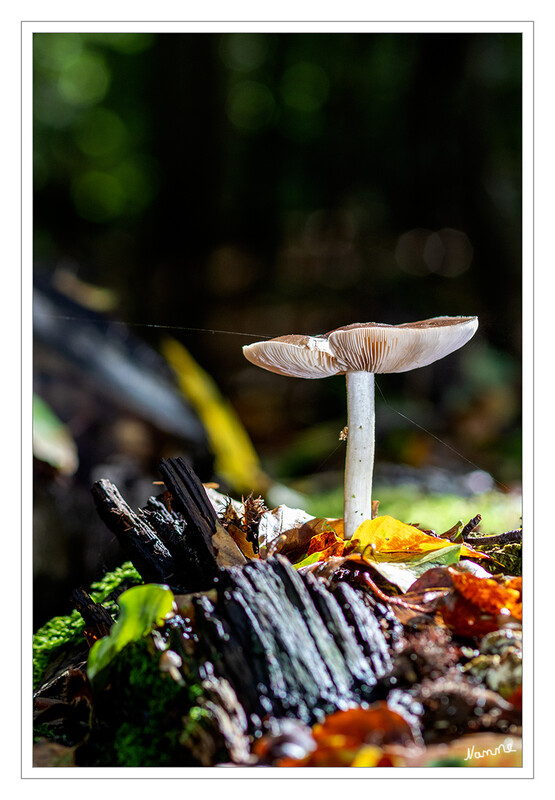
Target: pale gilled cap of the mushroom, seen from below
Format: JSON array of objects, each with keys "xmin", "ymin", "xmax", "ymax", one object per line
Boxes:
[{"xmin": 243, "ymin": 317, "xmax": 478, "ymax": 378}]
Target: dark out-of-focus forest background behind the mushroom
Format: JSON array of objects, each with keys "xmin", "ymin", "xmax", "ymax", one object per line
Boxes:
[{"xmin": 34, "ymin": 33, "xmax": 522, "ymax": 616}]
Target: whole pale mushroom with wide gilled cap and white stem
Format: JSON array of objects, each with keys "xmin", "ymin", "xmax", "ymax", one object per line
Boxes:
[{"xmin": 243, "ymin": 317, "xmax": 478, "ymax": 539}]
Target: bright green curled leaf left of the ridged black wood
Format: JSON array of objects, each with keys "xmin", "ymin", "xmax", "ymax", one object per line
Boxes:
[{"xmin": 87, "ymin": 583, "xmax": 174, "ymax": 680}]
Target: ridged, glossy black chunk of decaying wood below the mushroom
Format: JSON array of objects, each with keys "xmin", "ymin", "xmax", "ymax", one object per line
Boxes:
[{"xmin": 194, "ymin": 556, "xmax": 398, "ymax": 724}]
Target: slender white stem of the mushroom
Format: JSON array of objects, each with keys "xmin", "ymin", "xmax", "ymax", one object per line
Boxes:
[{"xmin": 343, "ymin": 370, "xmax": 375, "ymax": 539}]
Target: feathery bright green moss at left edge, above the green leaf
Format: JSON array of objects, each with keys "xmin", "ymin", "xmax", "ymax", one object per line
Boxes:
[{"xmin": 33, "ymin": 561, "xmax": 142, "ymax": 689}]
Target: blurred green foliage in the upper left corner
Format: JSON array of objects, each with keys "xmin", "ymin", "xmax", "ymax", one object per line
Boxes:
[{"xmin": 34, "ymin": 33, "xmax": 155, "ymax": 225}]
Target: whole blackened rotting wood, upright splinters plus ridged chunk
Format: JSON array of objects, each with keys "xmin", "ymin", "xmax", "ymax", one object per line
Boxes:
[{"xmin": 89, "ymin": 459, "xmax": 406, "ymax": 723}]
